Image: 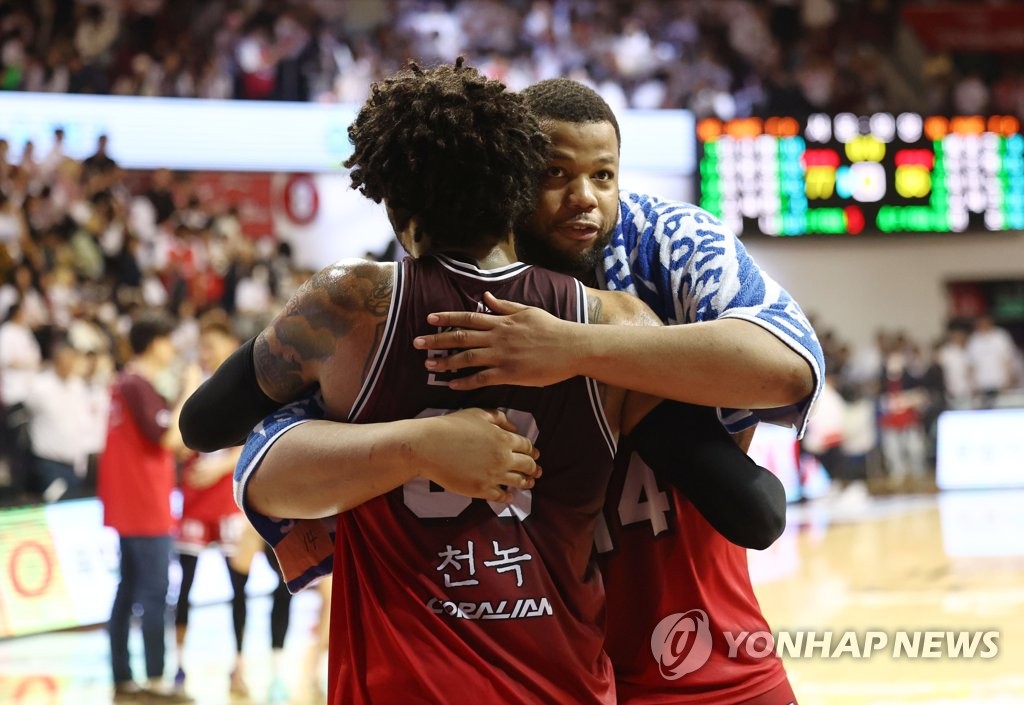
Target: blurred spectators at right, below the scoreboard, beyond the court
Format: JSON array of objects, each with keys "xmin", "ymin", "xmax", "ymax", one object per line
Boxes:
[{"xmin": 802, "ymin": 315, "xmax": 1024, "ymax": 498}]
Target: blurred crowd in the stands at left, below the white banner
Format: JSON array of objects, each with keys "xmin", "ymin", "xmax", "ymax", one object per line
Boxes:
[{"xmin": 0, "ymin": 130, "xmax": 308, "ymax": 501}]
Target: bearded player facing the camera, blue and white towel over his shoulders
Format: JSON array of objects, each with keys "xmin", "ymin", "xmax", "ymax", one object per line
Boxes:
[{"xmin": 407, "ymin": 79, "xmax": 823, "ymax": 705}]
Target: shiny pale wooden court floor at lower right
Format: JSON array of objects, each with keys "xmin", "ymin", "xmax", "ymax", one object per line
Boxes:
[{"xmin": 751, "ymin": 491, "xmax": 1024, "ymax": 705}]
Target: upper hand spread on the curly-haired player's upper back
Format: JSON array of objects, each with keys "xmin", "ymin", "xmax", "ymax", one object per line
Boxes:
[{"xmin": 413, "ymin": 293, "xmax": 579, "ymax": 390}]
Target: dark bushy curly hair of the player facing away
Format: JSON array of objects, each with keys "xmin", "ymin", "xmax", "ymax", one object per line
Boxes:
[{"xmin": 345, "ymin": 58, "xmax": 550, "ymax": 251}]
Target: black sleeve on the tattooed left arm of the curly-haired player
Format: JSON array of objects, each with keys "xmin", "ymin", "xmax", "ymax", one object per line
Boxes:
[{"xmin": 180, "ymin": 338, "xmax": 284, "ymax": 453}]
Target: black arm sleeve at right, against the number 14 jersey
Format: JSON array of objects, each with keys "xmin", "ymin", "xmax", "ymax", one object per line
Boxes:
[{"xmin": 632, "ymin": 402, "xmax": 785, "ymax": 549}]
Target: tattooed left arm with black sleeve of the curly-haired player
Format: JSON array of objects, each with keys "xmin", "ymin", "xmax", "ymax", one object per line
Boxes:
[{"xmin": 181, "ymin": 260, "xmax": 395, "ymax": 452}]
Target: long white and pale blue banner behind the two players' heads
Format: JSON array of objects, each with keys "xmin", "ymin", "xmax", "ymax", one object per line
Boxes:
[{"xmin": 0, "ymin": 92, "xmax": 696, "ymax": 175}]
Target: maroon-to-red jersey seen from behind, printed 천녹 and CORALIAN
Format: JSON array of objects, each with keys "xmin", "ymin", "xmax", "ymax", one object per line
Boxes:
[{"xmin": 330, "ymin": 256, "xmax": 614, "ymax": 705}]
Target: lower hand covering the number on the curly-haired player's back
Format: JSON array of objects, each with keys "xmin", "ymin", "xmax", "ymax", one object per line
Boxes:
[{"xmin": 413, "ymin": 409, "xmax": 542, "ymax": 502}]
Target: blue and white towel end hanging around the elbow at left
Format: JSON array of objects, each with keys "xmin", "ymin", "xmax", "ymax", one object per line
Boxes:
[{"xmin": 234, "ymin": 392, "xmax": 337, "ymax": 592}]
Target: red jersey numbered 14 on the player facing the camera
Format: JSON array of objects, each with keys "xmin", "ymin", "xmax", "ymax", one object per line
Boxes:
[{"xmin": 596, "ymin": 438, "xmax": 790, "ymax": 705}]
